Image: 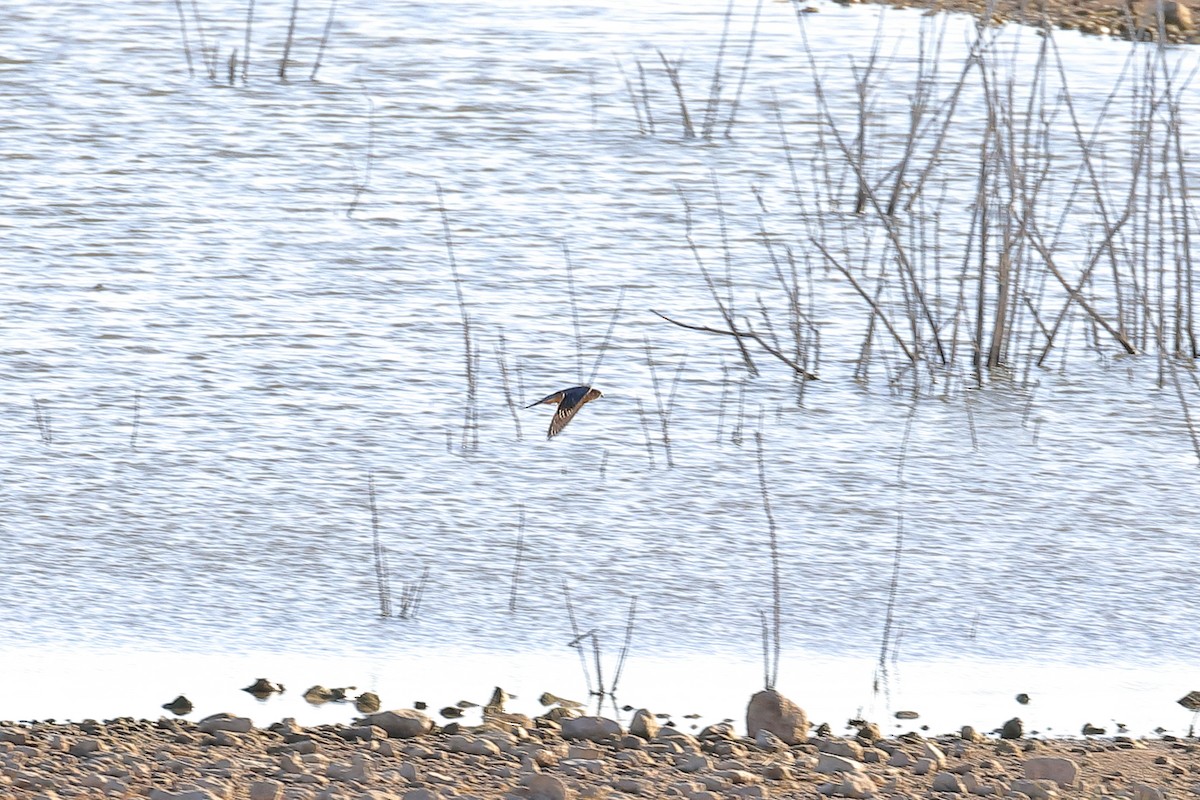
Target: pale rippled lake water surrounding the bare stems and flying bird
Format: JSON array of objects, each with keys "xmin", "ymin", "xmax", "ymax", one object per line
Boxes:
[{"xmin": 0, "ymin": 0, "xmax": 1200, "ymax": 733}]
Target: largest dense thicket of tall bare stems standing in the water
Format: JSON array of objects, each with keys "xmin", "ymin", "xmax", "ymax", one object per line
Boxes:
[{"xmin": 655, "ymin": 1, "xmax": 1200, "ymax": 455}]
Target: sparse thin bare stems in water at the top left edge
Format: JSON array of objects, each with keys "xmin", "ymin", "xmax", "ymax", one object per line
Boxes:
[{"xmin": 175, "ymin": 0, "xmax": 337, "ymax": 86}]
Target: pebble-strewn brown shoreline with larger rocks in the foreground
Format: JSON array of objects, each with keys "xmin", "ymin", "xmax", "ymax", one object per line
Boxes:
[{"xmin": 0, "ymin": 692, "xmax": 1200, "ymax": 800}]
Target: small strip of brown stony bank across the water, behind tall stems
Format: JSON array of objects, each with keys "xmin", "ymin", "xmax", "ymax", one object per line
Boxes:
[{"xmin": 835, "ymin": 0, "xmax": 1200, "ymax": 44}]
